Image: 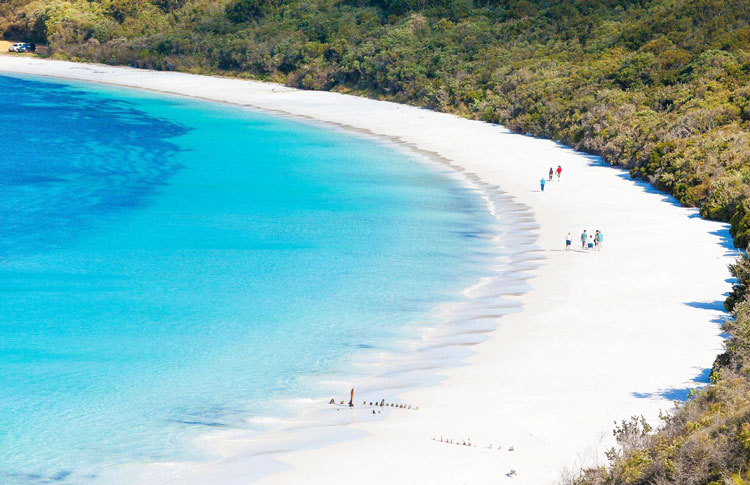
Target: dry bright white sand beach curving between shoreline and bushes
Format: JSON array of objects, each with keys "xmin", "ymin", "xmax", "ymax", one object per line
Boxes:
[{"xmin": 0, "ymin": 56, "xmax": 734, "ymax": 485}]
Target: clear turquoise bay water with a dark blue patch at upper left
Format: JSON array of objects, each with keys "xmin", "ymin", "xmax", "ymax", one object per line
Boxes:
[{"xmin": 0, "ymin": 76, "xmax": 500, "ymax": 484}]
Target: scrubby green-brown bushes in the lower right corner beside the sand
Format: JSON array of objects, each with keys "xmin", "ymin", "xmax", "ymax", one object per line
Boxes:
[{"xmin": 565, "ymin": 250, "xmax": 750, "ymax": 485}]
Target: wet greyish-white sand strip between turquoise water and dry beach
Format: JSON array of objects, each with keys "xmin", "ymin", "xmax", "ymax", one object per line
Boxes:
[{"xmin": 0, "ymin": 63, "xmax": 541, "ymax": 485}]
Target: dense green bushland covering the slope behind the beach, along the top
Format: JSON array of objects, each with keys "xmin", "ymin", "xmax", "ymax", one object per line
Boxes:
[{"xmin": 0, "ymin": 0, "xmax": 750, "ymax": 247}]
